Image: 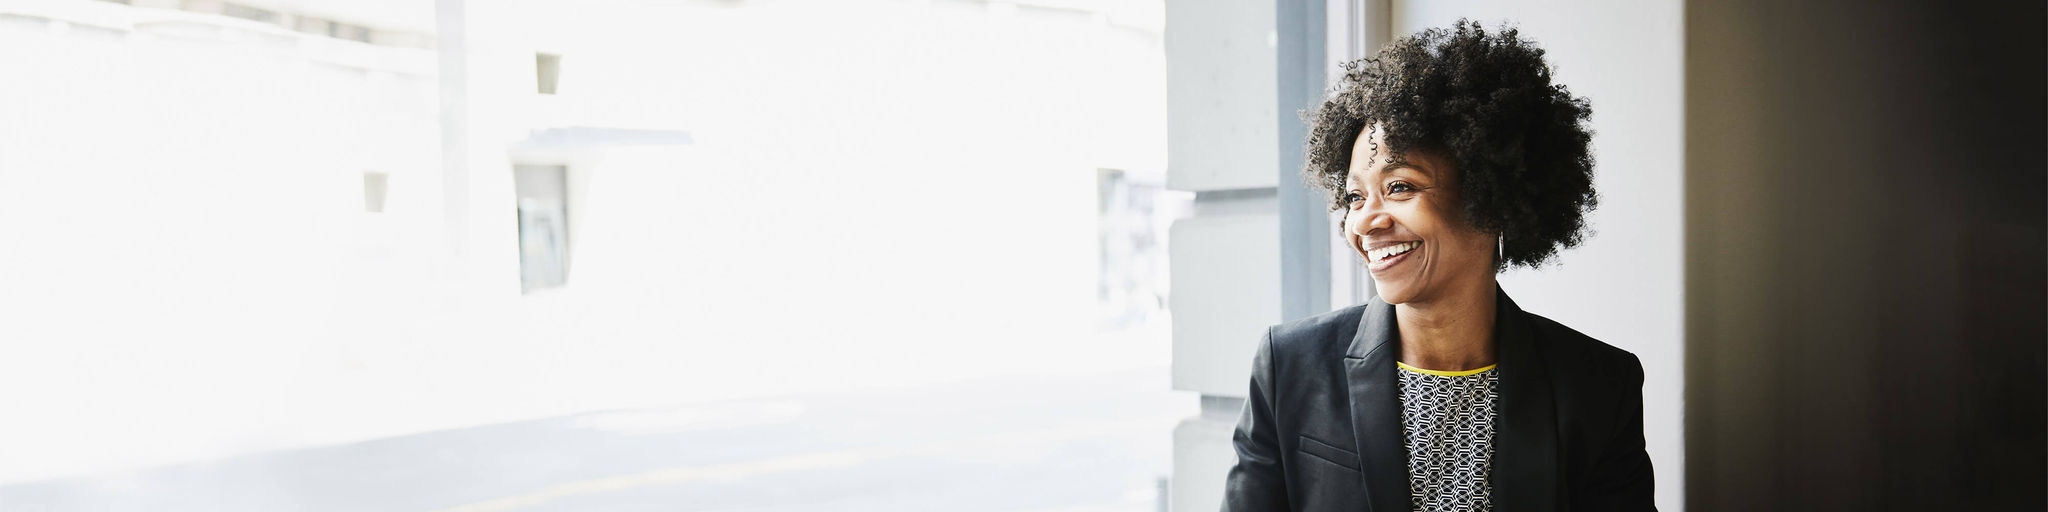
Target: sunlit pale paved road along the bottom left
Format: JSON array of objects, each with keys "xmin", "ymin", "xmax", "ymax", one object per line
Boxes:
[{"xmin": 0, "ymin": 369, "xmax": 1196, "ymax": 512}]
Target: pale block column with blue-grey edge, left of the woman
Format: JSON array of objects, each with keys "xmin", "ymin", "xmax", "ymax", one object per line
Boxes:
[{"xmin": 1165, "ymin": 0, "xmax": 1331, "ymax": 510}]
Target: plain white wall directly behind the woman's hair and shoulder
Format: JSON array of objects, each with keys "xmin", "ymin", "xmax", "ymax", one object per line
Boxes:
[{"xmin": 1393, "ymin": 0, "xmax": 1686, "ymax": 510}]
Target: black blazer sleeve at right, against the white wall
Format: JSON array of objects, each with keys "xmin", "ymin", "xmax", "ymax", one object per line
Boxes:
[{"xmin": 1579, "ymin": 354, "xmax": 1657, "ymax": 512}]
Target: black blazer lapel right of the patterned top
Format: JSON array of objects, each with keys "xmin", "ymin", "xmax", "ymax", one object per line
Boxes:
[{"xmin": 1490, "ymin": 291, "xmax": 1563, "ymax": 510}]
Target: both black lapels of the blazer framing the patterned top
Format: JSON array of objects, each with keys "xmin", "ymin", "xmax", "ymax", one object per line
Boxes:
[{"xmin": 1343, "ymin": 291, "xmax": 1563, "ymax": 512}]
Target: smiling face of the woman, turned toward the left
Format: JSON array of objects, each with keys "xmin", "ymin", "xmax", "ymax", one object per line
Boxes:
[{"xmin": 1343, "ymin": 127, "xmax": 1495, "ymax": 303}]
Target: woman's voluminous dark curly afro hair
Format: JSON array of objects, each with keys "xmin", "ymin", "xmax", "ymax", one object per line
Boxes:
[{"xmin": 1303, "ymin": 18, "xmax": 1597, "ymax": 272}]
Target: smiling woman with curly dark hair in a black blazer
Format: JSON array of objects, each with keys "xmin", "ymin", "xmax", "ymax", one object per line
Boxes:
[{"xmin": 1223, "ymin": 20, "xmax": 1655, "ymax": 512}]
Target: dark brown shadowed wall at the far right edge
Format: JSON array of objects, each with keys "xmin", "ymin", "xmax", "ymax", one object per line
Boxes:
[{"xmin": 1686, "ymin": 0, "xmax": 2048, "ymax": 510}]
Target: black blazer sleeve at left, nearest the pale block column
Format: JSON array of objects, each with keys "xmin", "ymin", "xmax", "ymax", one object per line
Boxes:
[{"xmin": 1223, "ymin": 328, "xmax": 1288, "ymax": 512}]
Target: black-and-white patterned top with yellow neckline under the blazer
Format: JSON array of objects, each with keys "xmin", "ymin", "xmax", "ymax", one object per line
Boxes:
[{"xmin": 1395, "ymin": 362, "xmax": 1499, "ymax": 512}]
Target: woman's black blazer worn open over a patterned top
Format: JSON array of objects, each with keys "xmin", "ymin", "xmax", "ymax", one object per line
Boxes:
[{"xmin": 1223, "ymin": 293, "xmax": 1657, "ymax": 512}]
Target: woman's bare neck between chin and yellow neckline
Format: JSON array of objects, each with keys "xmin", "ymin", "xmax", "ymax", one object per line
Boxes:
[{"xmin": 1395, "ymin": 274, "xmax": 1499, "ymax": 371}]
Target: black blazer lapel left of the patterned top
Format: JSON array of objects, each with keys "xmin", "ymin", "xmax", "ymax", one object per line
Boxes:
[{"xmin": 1343, "ymin": 297, "xmax": 1411, "ymax": 512}]
